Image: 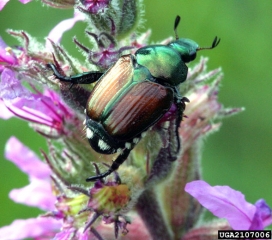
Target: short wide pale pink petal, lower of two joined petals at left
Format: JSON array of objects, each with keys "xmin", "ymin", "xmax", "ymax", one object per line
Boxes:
[{"xmin": 9, "ymin": 178, "xmax": 56, "ymax": 211}]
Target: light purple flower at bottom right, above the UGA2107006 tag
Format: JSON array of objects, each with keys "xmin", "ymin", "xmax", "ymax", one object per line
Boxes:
[{"xmin": 185, "ymin": 180, "xmax": 272, "ymax": 230}]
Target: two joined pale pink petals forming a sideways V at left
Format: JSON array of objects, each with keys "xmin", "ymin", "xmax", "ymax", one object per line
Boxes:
[{"xmin": 5, "ymin": 137, "xmax": 56, "ymax": 210}]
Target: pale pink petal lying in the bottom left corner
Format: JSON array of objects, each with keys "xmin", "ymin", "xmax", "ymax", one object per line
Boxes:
[{"xmin": 0, "ymin": 218, "xmax": 62, "ymax": 239}]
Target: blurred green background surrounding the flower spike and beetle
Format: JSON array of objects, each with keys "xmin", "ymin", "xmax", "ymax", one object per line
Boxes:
[{"xmin": 0, "ymin": 0, "xmax": 272, "ymax": 229}]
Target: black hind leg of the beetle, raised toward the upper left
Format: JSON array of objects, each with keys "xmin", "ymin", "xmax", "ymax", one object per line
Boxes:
[{"xmin": 46, "ymin": 63, "xmax": 104, "ymax": 85}]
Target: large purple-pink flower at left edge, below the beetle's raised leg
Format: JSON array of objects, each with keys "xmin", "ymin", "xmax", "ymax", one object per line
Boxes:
[{"xmin": 0, "ymin": 68, "xmax": 72, "ymax": 137}]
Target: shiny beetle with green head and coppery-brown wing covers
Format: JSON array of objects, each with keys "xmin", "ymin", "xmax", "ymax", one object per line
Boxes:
[{"xmin": 47, "ymin": 16, "xmax": 220, "ymax": 181}]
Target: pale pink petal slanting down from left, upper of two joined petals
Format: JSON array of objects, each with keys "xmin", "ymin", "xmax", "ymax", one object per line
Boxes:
[{"xmin": 5, "ymin": 137, "xmax": 51, "ymax": 179}]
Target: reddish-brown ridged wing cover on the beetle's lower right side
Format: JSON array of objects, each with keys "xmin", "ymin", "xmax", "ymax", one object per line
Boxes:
[{"xmin": 102, "ymin": 81, "xmax": 174, "ymax": 141}]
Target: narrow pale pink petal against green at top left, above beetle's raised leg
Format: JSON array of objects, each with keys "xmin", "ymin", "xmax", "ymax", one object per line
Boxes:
[{"xmin": 46, "ymin": 12, "xmax": 84, "ymax": 49}]
